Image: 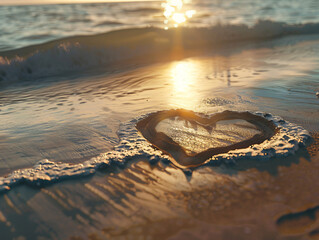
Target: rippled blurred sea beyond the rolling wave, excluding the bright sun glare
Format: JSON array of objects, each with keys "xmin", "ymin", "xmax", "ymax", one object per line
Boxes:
[{"xmin": 0, "ymin": 0, "xmax": 319, "ymax": 51}]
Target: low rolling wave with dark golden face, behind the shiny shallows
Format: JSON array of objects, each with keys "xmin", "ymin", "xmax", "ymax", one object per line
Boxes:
[{"xmin": 0, "ymin": 21, "xmax": 319, "ymax": 82}]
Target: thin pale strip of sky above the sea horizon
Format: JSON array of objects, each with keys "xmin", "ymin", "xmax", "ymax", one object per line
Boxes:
[{"xmin": 0, "ymin": 0, "xmax": 155, "ymax": 5}]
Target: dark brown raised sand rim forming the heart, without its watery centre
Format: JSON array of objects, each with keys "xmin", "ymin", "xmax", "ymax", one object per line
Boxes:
[{"xmin": 136, "ymin": 109, "xmax": 278, "ymax": 168}]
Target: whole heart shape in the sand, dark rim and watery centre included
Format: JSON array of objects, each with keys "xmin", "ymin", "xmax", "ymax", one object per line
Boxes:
[{"xmin": 136, "ymin": 109, "xmax": 276, "ymax": 168}]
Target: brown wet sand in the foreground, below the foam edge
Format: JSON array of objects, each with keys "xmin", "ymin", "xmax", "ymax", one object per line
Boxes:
[{"xmin": 0, "ymin": 140, "xmax": 319, "ymax": 239}]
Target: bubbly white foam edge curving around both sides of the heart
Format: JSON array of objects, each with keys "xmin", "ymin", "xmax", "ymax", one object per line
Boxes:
[{"xmin": 0, "ymin": 112, "xmax": 311, "ymax": 193}]
